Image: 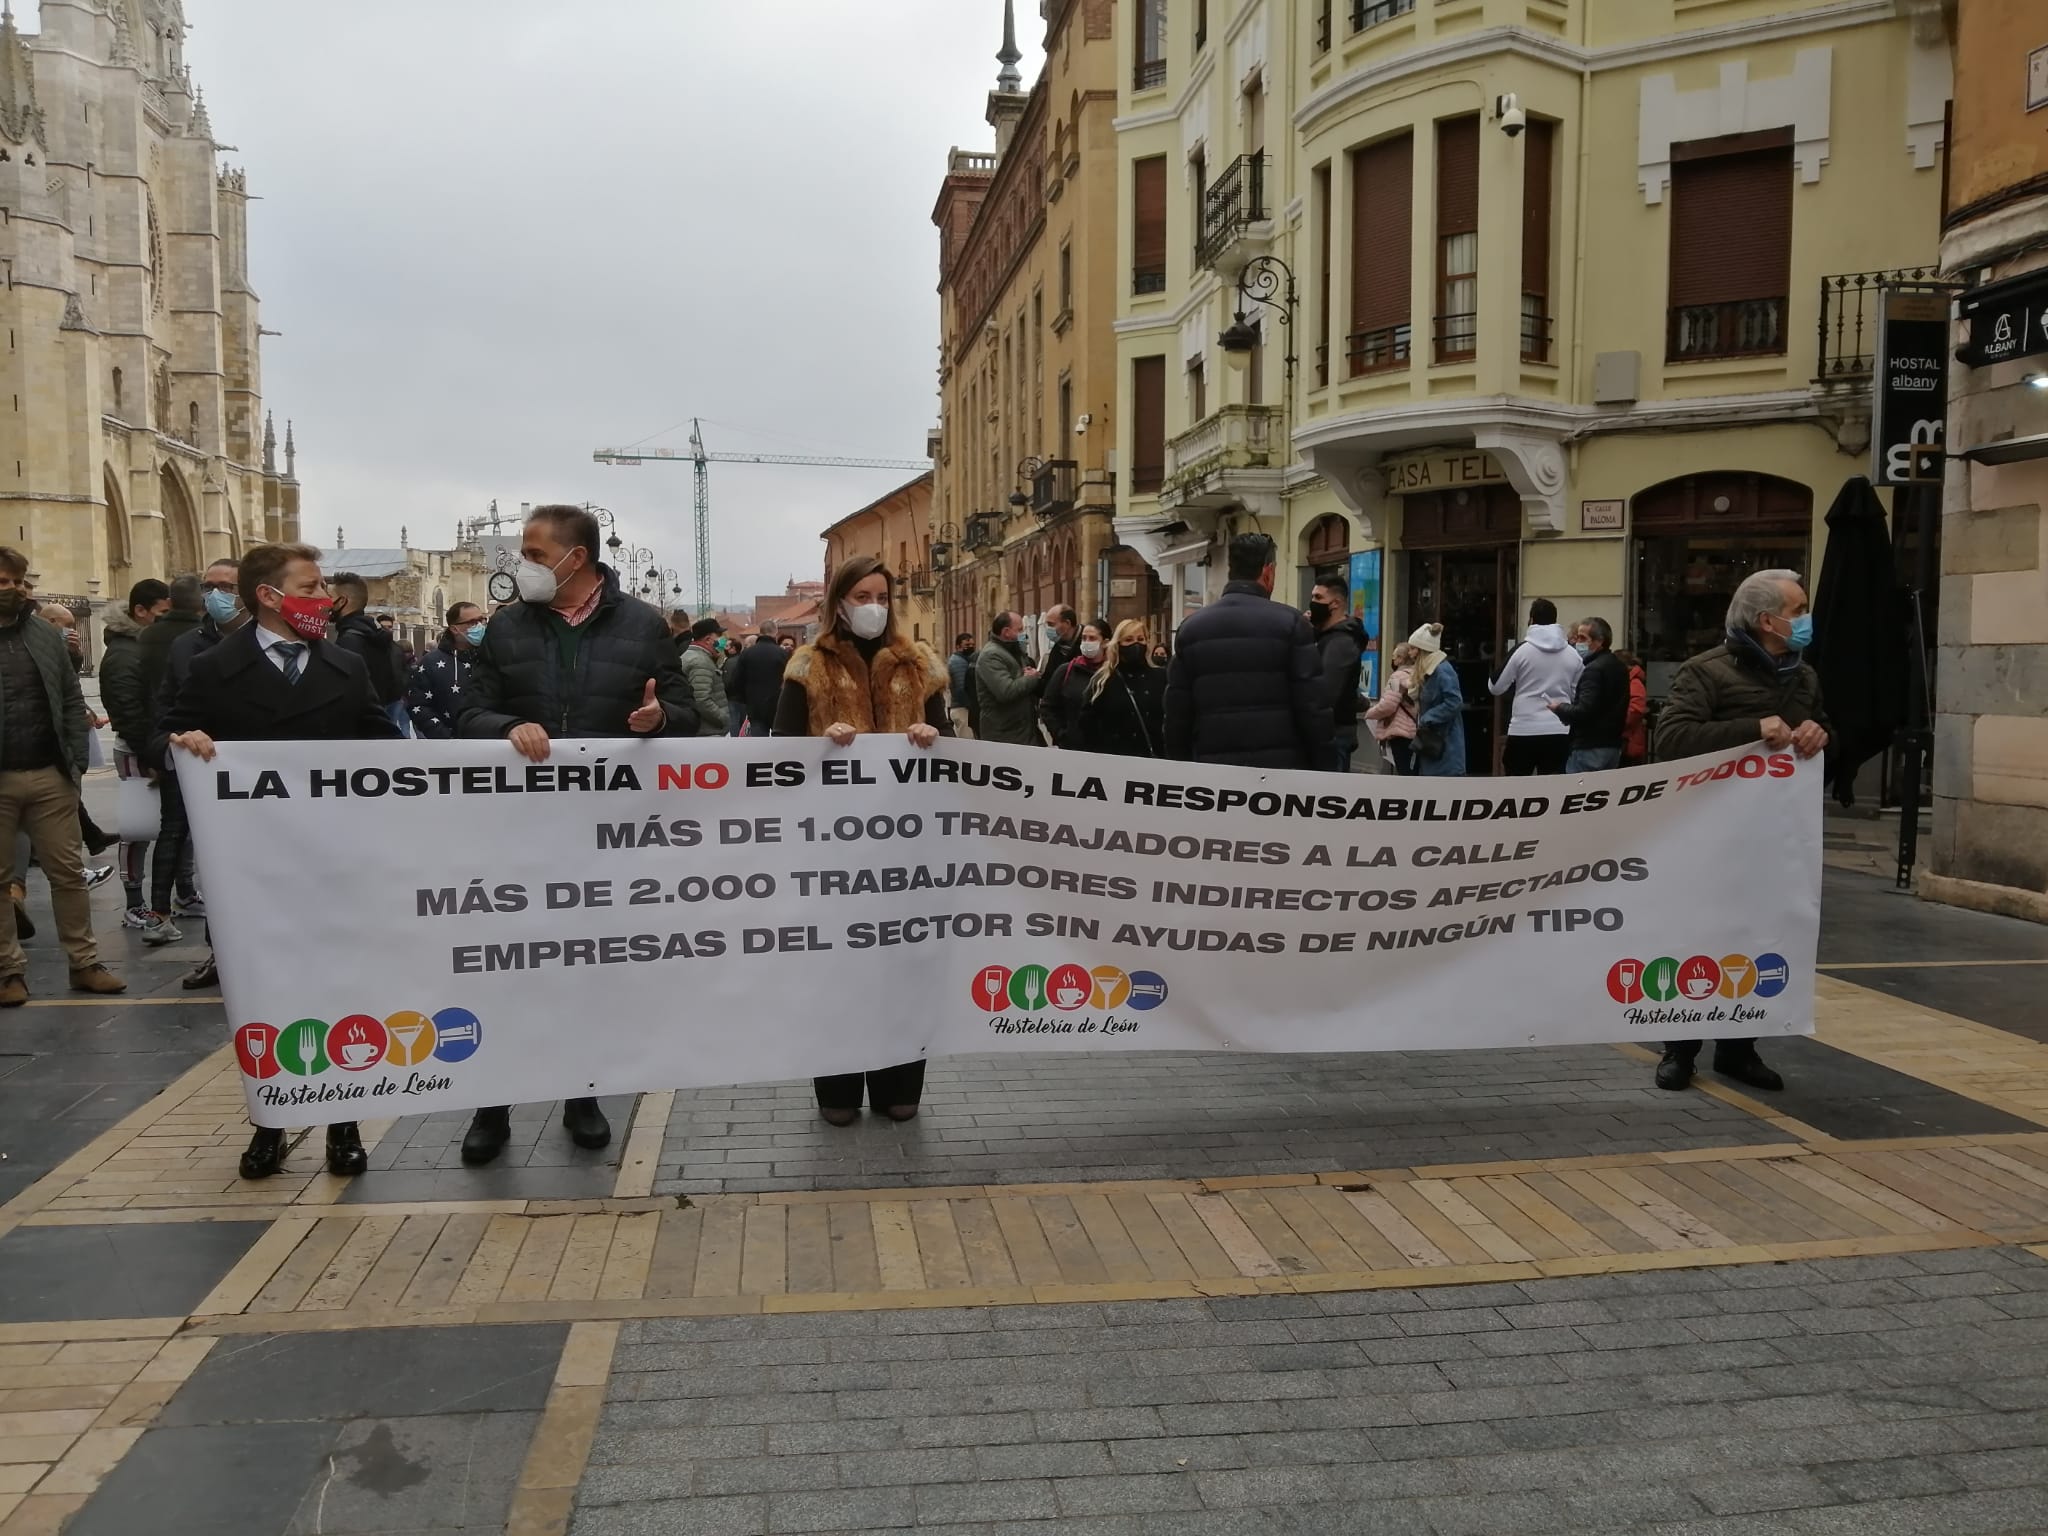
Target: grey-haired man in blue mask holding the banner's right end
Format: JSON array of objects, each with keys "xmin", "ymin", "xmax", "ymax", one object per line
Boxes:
[{"xmin": 1657, "ymin": 571, "xmax": 1833, "ymax": 1094}]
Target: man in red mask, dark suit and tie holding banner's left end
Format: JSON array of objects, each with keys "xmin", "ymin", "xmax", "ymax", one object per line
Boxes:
[{"xmin": 150, "ymin": 545, "xmax": 397, "ymax": 1180}]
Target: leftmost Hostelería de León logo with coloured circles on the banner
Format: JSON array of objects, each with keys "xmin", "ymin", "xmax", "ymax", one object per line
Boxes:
[{"xmin": 236, "ymin": 1008, "xmax": 483, "ymax": 1104}]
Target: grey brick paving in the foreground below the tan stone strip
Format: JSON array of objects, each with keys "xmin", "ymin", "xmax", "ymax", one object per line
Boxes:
[{"xmin": 571, "ymin": 1249, "xmax": 2048, "ymax": 1536}]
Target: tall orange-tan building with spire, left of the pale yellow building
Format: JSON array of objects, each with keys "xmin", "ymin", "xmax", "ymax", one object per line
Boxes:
[{"xmin": 929, "ymin": 0, "xmax": 1149, "ymax": 645}]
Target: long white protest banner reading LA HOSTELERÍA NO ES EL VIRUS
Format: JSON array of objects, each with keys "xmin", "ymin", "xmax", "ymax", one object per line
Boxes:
[{"xmin": 178, "ymin": 737, "xmax": 1821, "ymax": 1126}]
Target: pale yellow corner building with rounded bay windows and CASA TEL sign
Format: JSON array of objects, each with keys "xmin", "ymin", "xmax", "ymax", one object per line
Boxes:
[{"xmin": 1118, "ymin": 0, "xmax": 1952, "ymax": 770}]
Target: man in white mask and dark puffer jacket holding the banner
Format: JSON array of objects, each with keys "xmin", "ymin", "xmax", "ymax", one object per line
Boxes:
[{"xmin": 455, "ymin": 504, "xmax": 698, "ymax": 1165}]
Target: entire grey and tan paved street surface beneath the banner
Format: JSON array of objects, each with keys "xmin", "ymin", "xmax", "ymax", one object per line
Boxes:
[{"xmin": 0, "ymin": 870, "xmax": 2048, "ymax": 1536}]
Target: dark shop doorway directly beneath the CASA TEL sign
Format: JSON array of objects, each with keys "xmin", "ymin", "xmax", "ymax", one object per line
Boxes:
[{"xmin": 1399, "ymin": 485, "xmax": 1522, "ymax": 774}]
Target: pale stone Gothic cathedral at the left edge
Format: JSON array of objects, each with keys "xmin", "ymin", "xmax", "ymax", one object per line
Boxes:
[{"xmin": 0, "ymin": 0, "xmax": 299, "ymax": 610}]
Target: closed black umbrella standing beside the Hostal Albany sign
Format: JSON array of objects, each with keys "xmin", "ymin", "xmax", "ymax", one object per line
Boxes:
[{"xmin": 1806, "ymin": 475, "xmax": 1909, "ymax": 805}]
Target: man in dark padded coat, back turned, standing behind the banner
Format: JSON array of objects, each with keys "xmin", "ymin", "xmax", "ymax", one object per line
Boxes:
[{"xmin": 1165, "ymin": 532, "xmax": 1337, "ymax": 768}]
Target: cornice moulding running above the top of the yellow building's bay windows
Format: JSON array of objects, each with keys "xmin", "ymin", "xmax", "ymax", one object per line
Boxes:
[{"xmin": 1294, "ymin": 0, "xmax": 1901, "ymax": 133}]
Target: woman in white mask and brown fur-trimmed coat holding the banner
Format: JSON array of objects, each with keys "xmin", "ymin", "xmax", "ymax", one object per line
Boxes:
[{"xmin": 774, "ymin": 555, "xmax": 950, "ymax": 1126}]
